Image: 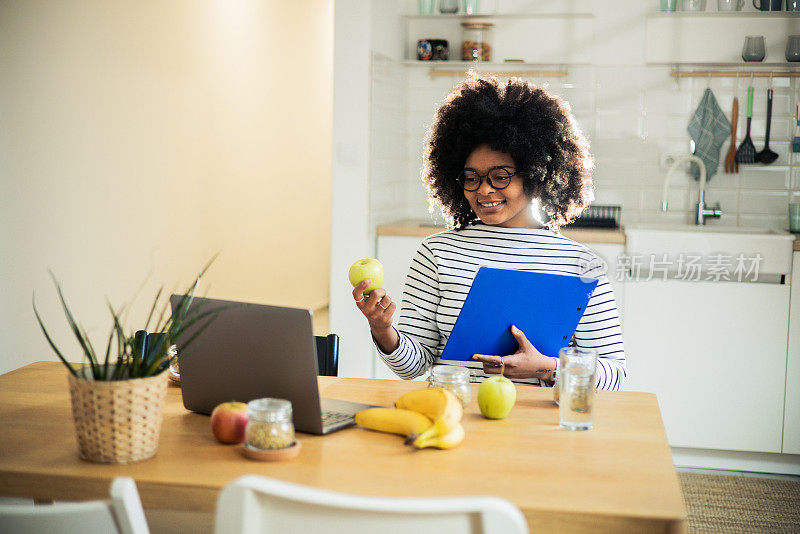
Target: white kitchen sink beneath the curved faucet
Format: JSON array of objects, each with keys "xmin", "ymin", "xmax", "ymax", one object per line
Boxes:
[{"xmin": 625, "ymin": 224, "xmax": 795, "ymax": 275}]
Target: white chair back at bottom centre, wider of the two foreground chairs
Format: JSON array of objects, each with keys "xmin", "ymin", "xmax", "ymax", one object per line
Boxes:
[{"xmin": 216, "ymin": 475, "xmax": 528, "ymax": 534}]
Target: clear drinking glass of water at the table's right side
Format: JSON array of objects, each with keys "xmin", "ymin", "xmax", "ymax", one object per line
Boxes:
[{"xmin": 558, "ymin": 347, "xmax": 597, "ymax": 430}]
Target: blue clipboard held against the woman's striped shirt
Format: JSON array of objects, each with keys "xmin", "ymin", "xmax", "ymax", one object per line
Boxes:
[{"xmin": 441, "ymin": 267, "xmax": 597, "ymax": 361}]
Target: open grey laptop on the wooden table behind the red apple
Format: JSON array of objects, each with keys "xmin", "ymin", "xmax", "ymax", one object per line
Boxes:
[{"xmin": 170, "ymin": 295, "xmax": 370, "ymax": 434}]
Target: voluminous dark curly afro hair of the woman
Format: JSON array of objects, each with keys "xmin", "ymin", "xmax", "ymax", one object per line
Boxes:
[{"xmin": 422, "ymin": 72, "xmax": 594, "ymax": 230}]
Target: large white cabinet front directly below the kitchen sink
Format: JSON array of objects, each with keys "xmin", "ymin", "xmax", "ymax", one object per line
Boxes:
[{"xmin": 625, "ymin": 280, "xmax": 790, "ymax": 452}]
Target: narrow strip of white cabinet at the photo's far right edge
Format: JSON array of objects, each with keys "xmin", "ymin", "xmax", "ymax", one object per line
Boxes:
[{"xmin": 783, "ymin": 252, "xmax": 800, "ymax": 454}]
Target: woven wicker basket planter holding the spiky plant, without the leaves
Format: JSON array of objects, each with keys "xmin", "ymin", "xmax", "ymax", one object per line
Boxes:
[{"xmin": 68, "ymin": 372, "xmax": 168, "ymax": 464}]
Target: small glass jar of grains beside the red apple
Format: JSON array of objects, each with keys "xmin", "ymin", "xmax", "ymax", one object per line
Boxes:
[{"xmin": 244, "ymin": 398, "xmax": 294, "ymax": 450}]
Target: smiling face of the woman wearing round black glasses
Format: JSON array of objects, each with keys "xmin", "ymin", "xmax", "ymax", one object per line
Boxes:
[{"xmin": 464, "ymin": 145, "xmax": 540, "ymax": 228}]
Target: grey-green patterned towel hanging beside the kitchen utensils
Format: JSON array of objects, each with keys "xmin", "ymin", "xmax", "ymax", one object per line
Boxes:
[{"xmin": 687, "ymin": 89, "xmax": 731, "ymax": 181}]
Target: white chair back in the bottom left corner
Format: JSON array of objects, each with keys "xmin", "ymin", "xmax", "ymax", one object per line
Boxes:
[{"xmin": 0, "ymin": 477, "xmax": 150, "ymax": 534}]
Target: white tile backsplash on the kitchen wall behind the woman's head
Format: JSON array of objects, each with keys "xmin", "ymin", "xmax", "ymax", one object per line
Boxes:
[{"xmin": 370, "ymin": 54, "xmax": 800, "ymax": 234}]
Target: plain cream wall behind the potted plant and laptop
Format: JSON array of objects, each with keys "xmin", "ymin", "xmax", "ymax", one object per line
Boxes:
[{"xmin": 0, "ymin": 0, "xmax": 333, "ymax": 372}]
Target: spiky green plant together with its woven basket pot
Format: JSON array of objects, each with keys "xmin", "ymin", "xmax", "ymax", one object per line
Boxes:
[{"xmin": 33, "ymin": 259, "xmax": 220, "ymax": 464}]
